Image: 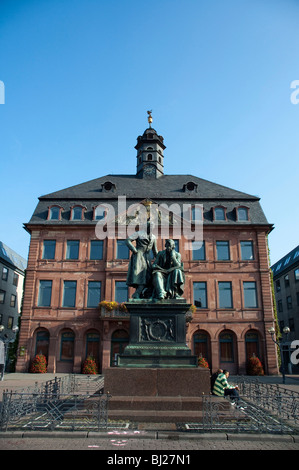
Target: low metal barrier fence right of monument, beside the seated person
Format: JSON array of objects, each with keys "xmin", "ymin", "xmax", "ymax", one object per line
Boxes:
[{"xmin": 199, "ymin": 376, "xmax": 299, "ymax": 434}]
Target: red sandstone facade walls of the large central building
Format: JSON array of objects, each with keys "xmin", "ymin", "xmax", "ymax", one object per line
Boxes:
[{"xmin": 17, "ymin": 227, "xmax": 277, "ymax": 374}]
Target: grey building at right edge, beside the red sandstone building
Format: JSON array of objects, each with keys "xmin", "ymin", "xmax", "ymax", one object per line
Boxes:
[{"xmin": 271, "ymin": 245, "xmax": 299, "ymax": 373}]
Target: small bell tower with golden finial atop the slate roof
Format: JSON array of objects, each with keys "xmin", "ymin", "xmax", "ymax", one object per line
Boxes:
[{"xmin": 135, "ymin": 111, "xmax": 166, "ymax": 178}]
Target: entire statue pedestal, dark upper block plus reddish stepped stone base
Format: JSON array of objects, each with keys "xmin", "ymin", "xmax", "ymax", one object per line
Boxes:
[{"xmin": 105, "ymin": 299, "xmax": 210, "ymax": 423}]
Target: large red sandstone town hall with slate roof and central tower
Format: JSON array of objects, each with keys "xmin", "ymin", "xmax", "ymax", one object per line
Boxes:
[{"xmin": 17, "ymin": 121, "xmax": 278, "ymax": 374}]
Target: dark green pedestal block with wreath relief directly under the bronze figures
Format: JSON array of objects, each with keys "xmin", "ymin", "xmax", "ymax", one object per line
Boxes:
[{"xmin": 118, "ymin": 299, "xmax": 197, "ymax": 368}]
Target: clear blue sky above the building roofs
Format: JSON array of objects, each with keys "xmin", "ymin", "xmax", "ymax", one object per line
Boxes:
[{"xmin": 0, "ymin": 0, "xmax": 299, "ymax": 263}]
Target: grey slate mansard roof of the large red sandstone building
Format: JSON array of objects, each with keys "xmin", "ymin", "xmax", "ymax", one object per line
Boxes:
[{"xmin": 26, "ymin": 175, "xmax": 270, "ymax": 226}]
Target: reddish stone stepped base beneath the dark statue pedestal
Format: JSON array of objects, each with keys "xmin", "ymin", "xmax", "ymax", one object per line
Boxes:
[{"xmin": 105, "ymin": 367, "xmax": 212, "ymax": 426}]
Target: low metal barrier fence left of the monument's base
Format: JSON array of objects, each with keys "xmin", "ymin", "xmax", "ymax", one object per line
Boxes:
[{"xmin": 0, "ymin": 375, "xmax": 110, "ymax": 431}]
